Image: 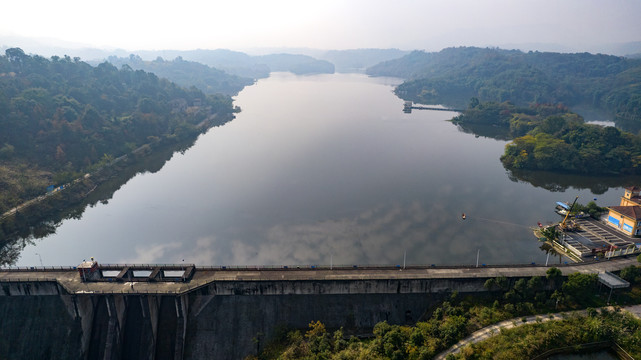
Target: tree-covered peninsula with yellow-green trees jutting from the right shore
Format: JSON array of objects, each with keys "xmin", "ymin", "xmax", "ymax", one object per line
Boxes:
[{"xmin": 452, "ymin": 98, "xmax": 641, "ymax": 175}]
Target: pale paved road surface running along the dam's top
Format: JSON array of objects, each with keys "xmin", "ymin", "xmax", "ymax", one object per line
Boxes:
[{"xmin": 0, "ymin": 258, "xmax": 638, "ymax": 294}]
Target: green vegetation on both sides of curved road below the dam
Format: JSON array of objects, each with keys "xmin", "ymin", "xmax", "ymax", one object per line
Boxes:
[{"xmin": 255, "ymin": 267, "xmax": 641, "ymax": 359}]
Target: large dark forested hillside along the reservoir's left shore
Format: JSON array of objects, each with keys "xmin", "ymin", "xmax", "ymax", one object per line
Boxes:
[{"xmin": 0, "ymin": 48, "xmax": 233, "ymax": 210}]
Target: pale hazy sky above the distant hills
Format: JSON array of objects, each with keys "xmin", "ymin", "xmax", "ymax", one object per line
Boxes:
[{"xmin": 0, "ymin": 0, "xmax": 641, "ymax": 50}]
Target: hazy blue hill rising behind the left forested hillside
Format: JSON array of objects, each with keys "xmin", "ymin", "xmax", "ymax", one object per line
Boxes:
[{"xmin": 107, "ymin": 54, "xmax": 254, "ymax": 95}]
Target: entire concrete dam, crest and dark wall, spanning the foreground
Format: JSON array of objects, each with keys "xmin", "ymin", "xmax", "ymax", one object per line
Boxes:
[{"xmin": 0, "ymin": 258, "xmax": 637, "ymax": 359}]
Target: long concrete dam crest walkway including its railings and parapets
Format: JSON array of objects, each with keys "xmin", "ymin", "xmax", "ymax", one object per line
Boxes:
[{"xmin": 0, "ymin": 257, "xmax": 638, "ymax": 295}]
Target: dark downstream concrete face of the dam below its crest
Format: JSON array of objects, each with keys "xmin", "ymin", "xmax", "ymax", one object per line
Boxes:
[{"xmin": 0, "ymin": 280, "xmax": 483, "ymax": 359}]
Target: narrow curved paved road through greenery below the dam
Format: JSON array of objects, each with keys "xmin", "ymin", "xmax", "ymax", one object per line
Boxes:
[{"xmin": 434, "ymin": 305, "xmax": 641, "ymax": 360}]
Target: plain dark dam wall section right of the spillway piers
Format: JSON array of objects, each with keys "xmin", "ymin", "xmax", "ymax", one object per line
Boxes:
[{"xmin": 180, "ymin": 279, "xmax": 486, "ymax": 359}]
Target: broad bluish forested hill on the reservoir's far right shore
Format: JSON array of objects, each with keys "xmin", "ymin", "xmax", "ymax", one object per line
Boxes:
[{"xmin": 367, "ymin": 47, "xmax": 641, "ymax": 127}]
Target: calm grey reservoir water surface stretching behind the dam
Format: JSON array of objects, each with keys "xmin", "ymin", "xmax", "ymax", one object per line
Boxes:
[{"xmin": 16, "ymin": 73, "xmax": 628, "ymax": 266}]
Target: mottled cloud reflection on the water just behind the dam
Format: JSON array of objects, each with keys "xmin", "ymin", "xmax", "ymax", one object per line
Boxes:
[{"xmin": 162, "ymin": 201, "xmax": 523, "ymax": 265}]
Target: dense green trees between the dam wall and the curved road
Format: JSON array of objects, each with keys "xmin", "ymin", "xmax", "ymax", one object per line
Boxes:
[{"xmin": 251, "ymin": 268, "xmax": 641, "ymax": 359}]
